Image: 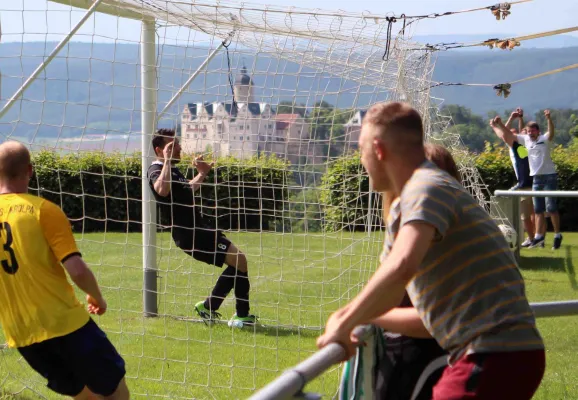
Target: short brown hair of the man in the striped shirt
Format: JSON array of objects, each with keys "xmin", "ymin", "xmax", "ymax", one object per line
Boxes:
[{"xmin": 363, "ymin": 102, "xmax": 423, "ymax": 145}]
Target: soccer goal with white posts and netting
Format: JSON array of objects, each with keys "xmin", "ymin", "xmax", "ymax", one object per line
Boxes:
[{"xmin": 0, "ymin": 0, "xmax": 502, "ymax": 399}]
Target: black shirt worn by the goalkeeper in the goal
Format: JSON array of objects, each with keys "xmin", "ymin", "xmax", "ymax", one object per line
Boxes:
[{"xmin": 147, "ymin": 161, "xmax": 201, "ymax": 248}]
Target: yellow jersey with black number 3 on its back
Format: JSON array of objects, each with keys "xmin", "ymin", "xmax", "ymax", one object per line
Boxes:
[{"xmin": 0, "ymin": 193, "xmax": 89, "ymax": 347}]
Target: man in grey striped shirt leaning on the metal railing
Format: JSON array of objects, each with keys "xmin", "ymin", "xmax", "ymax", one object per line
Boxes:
[{"xmin": 318, "ymin": 103, "xmax": 545, "ymax": 400}]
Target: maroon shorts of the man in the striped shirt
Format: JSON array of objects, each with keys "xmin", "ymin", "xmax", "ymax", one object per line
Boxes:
[{"xmin": 433, "ymin": 350, "xmax": 546, "ymax": 400}]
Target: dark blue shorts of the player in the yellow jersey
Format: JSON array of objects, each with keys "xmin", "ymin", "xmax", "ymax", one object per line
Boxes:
[{"xmin": 18, "ymin": 319, "xmax": 126, "ymax": 397}]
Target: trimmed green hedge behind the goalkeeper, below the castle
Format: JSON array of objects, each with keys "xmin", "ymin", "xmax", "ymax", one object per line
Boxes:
[{"xmin": 30, "ymin": 151, "xmax": 289, "ymax": 232}]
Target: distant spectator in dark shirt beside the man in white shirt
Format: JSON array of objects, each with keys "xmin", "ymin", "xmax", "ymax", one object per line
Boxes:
[{"xmin": 498, "ymin": 108, "xmax": 536, "ymax": 247}]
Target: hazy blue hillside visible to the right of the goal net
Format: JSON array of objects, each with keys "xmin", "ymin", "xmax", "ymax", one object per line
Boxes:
[{"xmin": 432, "ymin": 47, "xmax": 578, "ymax": 114}]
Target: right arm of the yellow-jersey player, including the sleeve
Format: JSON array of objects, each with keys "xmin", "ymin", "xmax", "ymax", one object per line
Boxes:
[{"xmin": 40, "ymin": 201, "xmax": 106, "ymax": 314}]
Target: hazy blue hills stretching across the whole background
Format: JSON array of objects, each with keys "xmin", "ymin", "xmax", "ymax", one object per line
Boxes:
[{"xmin": 0, "ymin": 42, "xmax": 578, "ymax": 138}]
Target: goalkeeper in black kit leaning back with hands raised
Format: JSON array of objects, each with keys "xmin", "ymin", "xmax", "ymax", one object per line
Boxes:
[{"xmin": 147, "ymin": 129, "xmax": 256, "ymax": 327}]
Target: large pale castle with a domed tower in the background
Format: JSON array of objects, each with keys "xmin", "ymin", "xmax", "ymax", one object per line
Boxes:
[{"xmin": 181, "ymin": 67, "xmax": 323, "ymax": 164}]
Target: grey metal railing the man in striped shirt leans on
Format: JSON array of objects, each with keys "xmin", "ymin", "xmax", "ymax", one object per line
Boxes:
[{"xmin": 249, "ymin": 300, "xmax": 578, "ymax": 400}]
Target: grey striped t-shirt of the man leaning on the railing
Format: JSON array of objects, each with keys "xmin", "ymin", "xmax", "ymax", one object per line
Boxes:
[{"xmin": 382, "ymin": 161, "xmax": 544, "ymax": 362}]
